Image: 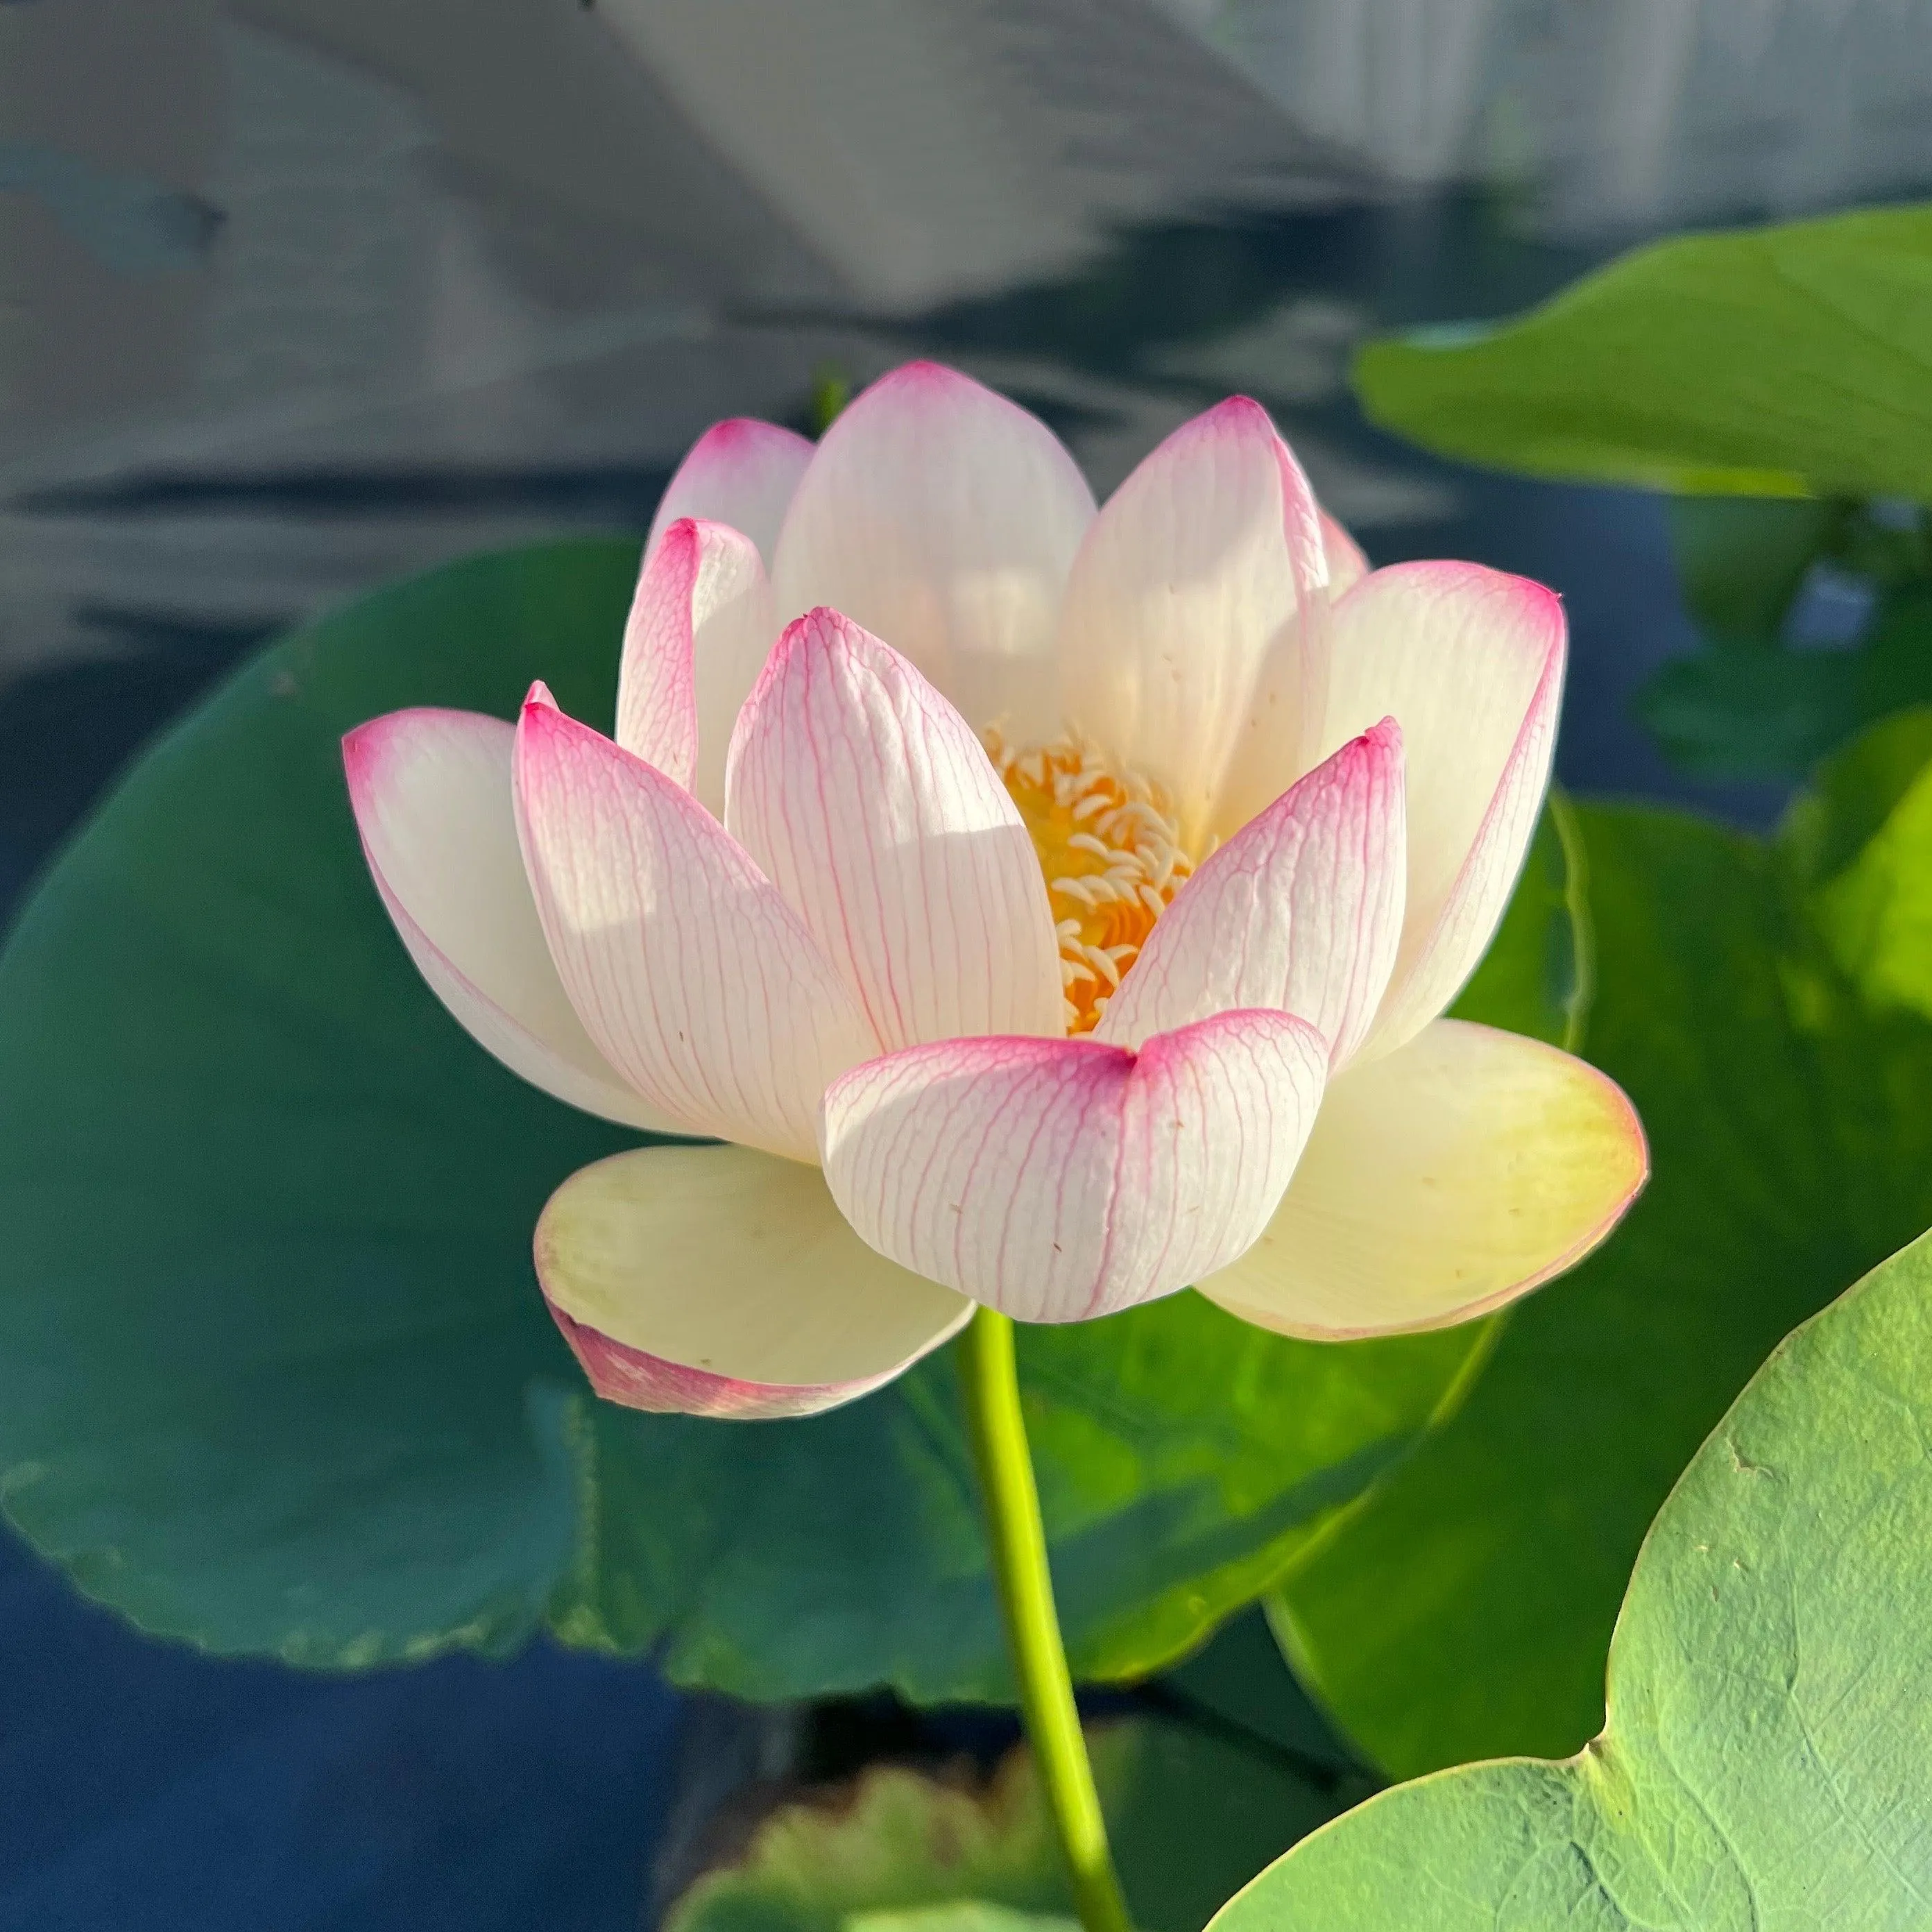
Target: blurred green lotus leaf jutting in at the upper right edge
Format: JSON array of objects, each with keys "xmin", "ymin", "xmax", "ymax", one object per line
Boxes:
[{"xmin": 1354, "ymin": 207, "xmax": 1932, "ymax": 502}]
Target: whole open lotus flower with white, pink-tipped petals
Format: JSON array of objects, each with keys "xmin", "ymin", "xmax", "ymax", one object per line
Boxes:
[{"xmin": 346, "ymin": 364, "xmax": 1646, "ymax": 1416}]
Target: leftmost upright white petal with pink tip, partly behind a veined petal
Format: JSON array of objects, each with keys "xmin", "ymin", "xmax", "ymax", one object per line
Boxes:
[{"xmin": 342, "ymin": 711, "xmax": 684, "ymax": 1134}]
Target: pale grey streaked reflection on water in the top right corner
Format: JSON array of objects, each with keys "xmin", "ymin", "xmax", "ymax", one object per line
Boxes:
[{"xmin": 1167, "ymin": 0, "xmax": 1932, "ymax": 234}]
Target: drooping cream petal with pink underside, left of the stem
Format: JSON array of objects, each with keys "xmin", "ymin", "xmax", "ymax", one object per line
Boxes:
[{"xmin": 537, "ymin": 1147, "xmax": 974, "ymax": 1418}]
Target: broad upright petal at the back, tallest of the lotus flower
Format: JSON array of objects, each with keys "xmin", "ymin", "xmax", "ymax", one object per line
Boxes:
[{"xmin": 771, "ymin": 364, "xmax": 1093, "ymax": 742}]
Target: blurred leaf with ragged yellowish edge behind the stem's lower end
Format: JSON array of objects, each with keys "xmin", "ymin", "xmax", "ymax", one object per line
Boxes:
[{"xmin": 665, "ymin": 1720, "xmax": 1335, "ymax": 1932}]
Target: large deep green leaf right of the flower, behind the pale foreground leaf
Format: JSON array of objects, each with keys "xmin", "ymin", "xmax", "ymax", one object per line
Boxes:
[{"xmin": 1277, "ymin": 715, "xmax": 1932, "ymax": 1775}]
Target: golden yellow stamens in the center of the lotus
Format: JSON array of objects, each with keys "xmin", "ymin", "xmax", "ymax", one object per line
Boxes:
[{"xmin": 985, "ymin": 730, "xmax": 1194, "ymax": 1034}]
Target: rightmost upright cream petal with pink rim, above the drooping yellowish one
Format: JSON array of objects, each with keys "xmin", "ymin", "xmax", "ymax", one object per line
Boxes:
[{"xmin": 1327, "ymin": 564, "xmax": 1565, "ymax": 1053}]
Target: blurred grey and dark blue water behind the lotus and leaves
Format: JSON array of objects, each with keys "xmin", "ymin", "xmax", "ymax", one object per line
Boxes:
[{"xmin": 11, "ymin": 0, "xmax": 1932, "ymax": 1932}]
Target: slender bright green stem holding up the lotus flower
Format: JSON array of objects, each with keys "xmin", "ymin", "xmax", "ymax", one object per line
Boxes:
[{"xmin": 958, "ymin": 1308, "xmax": 1130, "ymax": 1932}]
